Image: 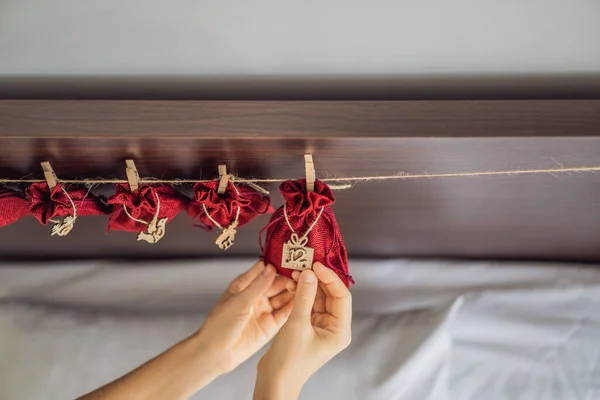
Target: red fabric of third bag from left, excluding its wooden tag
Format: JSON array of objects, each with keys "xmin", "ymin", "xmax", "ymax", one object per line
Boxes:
[{"xmin": 107, "ymin": 183, "xmax": 188, "ymax": 232}]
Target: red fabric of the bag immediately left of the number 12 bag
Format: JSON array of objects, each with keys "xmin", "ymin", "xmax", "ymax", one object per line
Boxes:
[{"xmin": 188, "ymin": 181, "xmax": 273, "ymax": 230}]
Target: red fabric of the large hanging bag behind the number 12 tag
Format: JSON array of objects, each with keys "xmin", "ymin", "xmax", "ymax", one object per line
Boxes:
[{"xmin": 260, "ymin": 179, "xmax": 354, "ymax": 286}]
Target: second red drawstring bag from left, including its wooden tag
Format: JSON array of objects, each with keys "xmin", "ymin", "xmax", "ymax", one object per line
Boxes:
[{"xmin": 25, "ymin": 182, "xmax": 107, "ymax": 236}]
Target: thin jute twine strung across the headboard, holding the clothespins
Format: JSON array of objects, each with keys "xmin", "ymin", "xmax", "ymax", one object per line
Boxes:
[{"xmin": 0, "ymin": 166, "xmax": 600, "ymax": 189}]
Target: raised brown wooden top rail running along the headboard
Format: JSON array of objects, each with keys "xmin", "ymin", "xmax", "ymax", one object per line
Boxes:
[{"xmin": 0, "ymin": 100, "xmax": 600, "ymax": 139}]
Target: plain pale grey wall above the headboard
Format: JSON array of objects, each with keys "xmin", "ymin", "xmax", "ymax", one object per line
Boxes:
[{"xmin": 0, "ymin": 0, "xmax": 600, "ymax": 77}]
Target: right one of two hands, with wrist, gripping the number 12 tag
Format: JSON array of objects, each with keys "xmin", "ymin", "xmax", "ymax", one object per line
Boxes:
[{"xmin": 254, "ymin": 263, "xmax": 352, "ymax": 400}]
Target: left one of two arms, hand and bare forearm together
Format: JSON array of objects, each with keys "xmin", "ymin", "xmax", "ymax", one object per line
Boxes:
[{"xmin": 81, "ymin": 263, "xmax": 294, "ymax": 400}]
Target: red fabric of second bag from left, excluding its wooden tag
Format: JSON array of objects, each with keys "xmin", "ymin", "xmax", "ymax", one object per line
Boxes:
[{"xmin": 25, "ymin": 182, "xmax": 106, "ymax": 225}]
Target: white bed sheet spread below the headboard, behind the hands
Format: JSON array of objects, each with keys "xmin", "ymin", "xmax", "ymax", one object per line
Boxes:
[{"xmin": 0, "ymin": 260, "xmax": 600, "ymax": 400}]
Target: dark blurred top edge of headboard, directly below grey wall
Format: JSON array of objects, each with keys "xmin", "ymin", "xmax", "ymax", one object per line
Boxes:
[{"xmin": 0, "ymin": 71, "xmax": 600, "ymax": 101}]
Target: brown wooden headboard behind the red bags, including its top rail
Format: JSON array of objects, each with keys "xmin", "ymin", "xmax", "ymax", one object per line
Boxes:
[{"xmin": 0, "ymin": 100, "xmax": 600, "ymax": 261}]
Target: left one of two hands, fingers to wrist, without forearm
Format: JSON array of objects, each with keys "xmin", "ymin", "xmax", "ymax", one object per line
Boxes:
[{"xmin": 195, "ymin": 262, "xmax": 294, "ymax": 373}]
